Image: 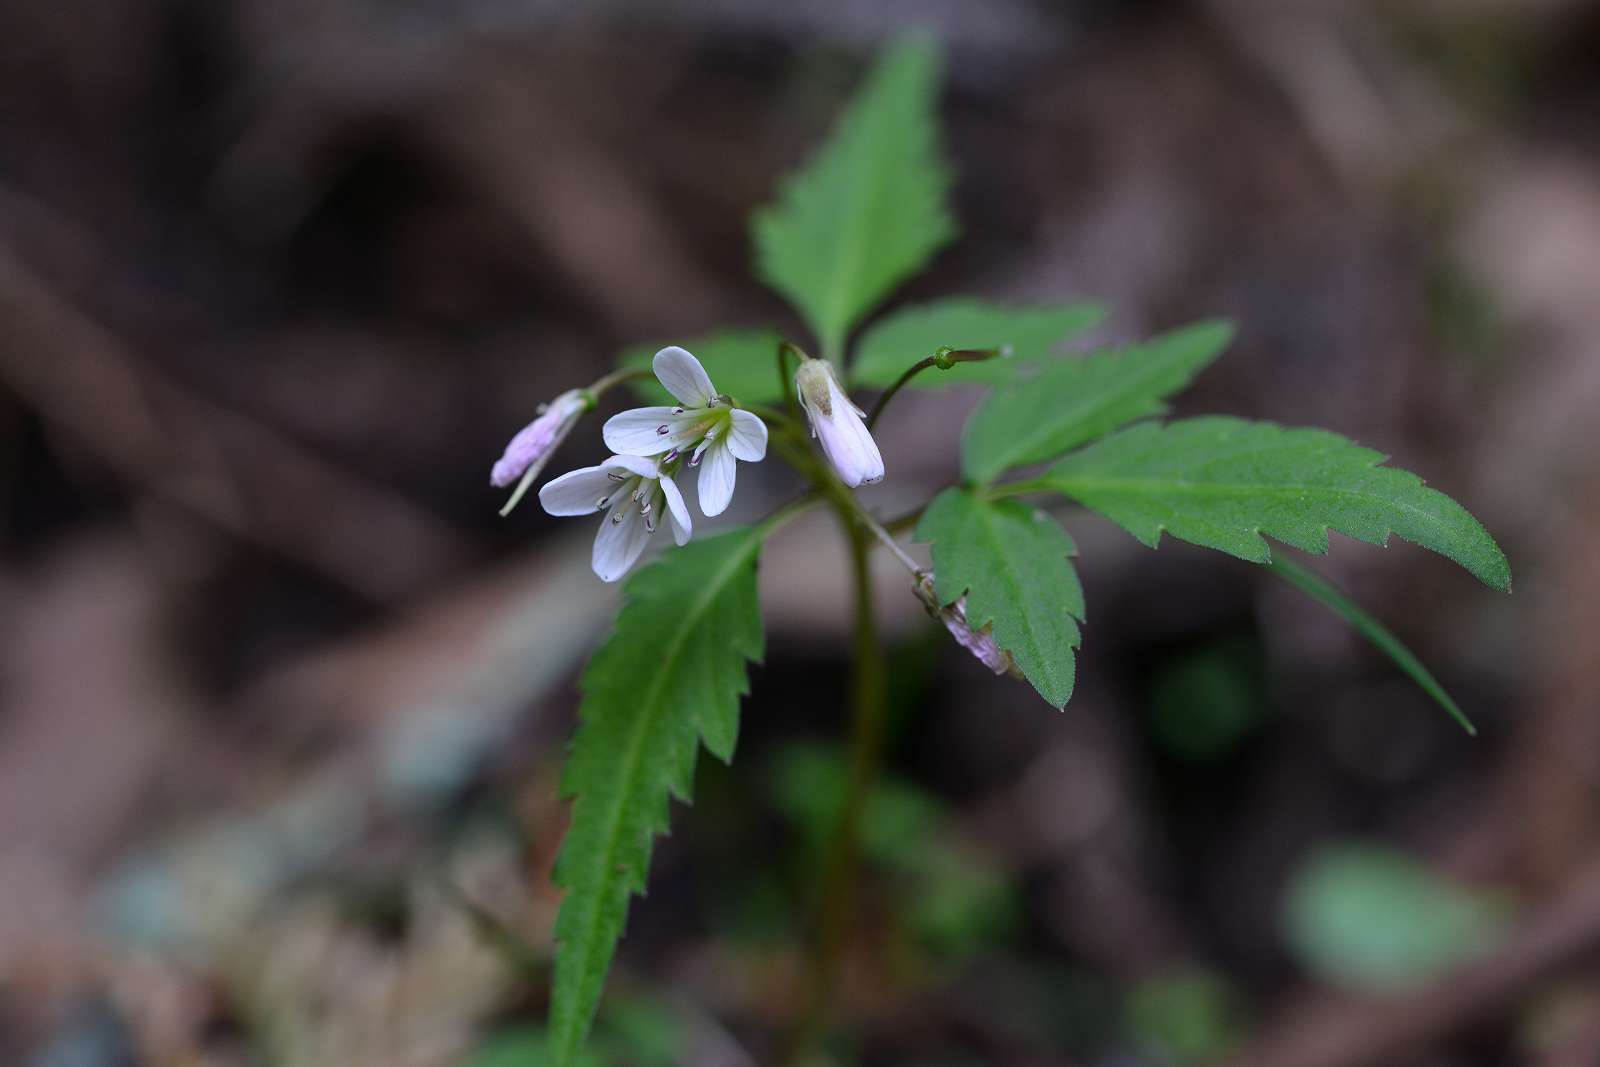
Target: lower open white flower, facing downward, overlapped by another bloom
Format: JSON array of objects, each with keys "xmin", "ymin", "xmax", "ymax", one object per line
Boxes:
[{"xmin": 539, "ymin": 456, "xmax": 691, "ymax": 582}]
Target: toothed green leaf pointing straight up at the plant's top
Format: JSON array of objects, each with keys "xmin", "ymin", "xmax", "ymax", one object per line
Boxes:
[{"xmin": 754, "ymin": 38, "xmax": 955, "ymax": 360}]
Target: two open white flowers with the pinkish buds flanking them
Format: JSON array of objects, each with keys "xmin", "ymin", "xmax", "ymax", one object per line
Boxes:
[{"xmin": 490, "ymin": 346, "xmax": 883, "ymax": 582}]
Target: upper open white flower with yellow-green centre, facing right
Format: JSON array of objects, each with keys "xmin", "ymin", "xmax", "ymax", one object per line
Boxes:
[{"xmin": 605, "ymin": 346, "xmax": 766, "ymax": 515}]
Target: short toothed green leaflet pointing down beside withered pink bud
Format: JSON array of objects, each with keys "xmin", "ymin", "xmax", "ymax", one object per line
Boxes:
[{"xmin": 917, "ymin": 490, "xmax": 1083, "ymax": 707}]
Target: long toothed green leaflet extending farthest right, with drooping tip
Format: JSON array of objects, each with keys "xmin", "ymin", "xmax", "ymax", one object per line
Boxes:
[{"xmin": 1040, "ymin": 416, "xmax": 1510, "ymax": 590}]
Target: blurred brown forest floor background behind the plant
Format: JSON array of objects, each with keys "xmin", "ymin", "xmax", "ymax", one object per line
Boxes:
[{"xmin": 0, "ymin": 0, "xmax": 1600, "ymax": 1067}]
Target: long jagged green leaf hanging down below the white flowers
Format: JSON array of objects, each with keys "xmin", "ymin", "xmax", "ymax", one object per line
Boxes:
[{"xmin": 550, "ymin": 526, "xmax": 766, "ymax": 1064}]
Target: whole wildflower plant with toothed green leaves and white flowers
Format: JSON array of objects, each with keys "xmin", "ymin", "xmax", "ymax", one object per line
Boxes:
[{"xmin": 493, "ymin": 42, "xmax": 1510, "ymax": 1064}]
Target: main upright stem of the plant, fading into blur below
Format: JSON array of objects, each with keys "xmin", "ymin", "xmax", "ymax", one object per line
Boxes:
[{"xmin": 784, "ymin": 505, "xmax": 886, "ymax": 1064}]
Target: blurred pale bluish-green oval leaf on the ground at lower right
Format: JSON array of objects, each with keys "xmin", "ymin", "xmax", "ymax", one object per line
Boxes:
[{"xmin": 1283, "ymin": 841, "xmax": 1512, "ymax": 992}]
